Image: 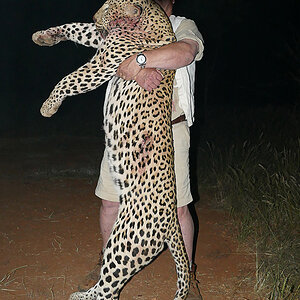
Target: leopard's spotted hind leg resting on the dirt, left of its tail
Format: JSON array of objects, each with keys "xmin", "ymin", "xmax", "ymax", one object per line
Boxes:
[{"xmin": 69, "ymin": 211, "xmax": 164, "ymax": 300}]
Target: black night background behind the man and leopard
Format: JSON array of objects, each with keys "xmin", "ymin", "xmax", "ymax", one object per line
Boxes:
[{"xmin": 0, "ymin": 0, "xmax": 299, "ymax": 137}]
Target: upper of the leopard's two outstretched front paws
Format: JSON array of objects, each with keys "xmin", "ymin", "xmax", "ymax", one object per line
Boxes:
[{"xmin": 32, "ymin": 27, "xmax": 66, "ymax": 47}]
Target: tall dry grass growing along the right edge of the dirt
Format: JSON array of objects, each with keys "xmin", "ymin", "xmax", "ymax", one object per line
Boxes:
[{"xmin": 199, "ymin": 107, "xmax": 300, "ymax": 300}]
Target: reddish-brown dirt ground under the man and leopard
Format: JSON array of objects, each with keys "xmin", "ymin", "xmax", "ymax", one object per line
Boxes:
[{"xmin": 0, "ymin": 139, "xmax": 257, "ymax": 300}]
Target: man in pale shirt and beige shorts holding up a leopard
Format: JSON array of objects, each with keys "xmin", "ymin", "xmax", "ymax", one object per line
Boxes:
[{"xmin": 80, "ymin": 0, "xmax": 203, "ymax": 300}]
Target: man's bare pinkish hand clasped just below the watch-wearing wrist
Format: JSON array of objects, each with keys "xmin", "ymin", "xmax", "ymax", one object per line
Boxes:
[{"xmin": 135, "ymin": 68, "xmax": 163, "ymax": 92}]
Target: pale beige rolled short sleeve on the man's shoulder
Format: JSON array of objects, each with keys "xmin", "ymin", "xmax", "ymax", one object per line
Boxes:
[{"xmin": 175, "ymin": 19, "xmax": 204, "ymax": 61}]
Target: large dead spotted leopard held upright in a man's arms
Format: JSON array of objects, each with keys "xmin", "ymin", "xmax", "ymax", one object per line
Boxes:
[{"xmin": 33, "ymin": 0, "xmax": 189, "ymax": 300}]
